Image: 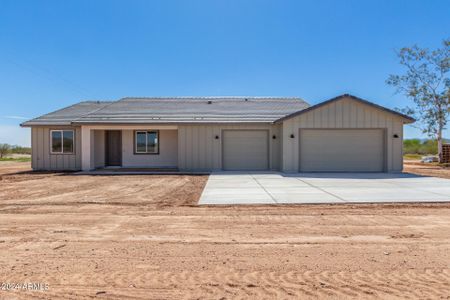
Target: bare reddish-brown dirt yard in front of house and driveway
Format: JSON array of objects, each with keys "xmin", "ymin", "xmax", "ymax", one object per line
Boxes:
[{"xmin": 0, "ymin": 163, "xmax": 450, "ymax": 299}]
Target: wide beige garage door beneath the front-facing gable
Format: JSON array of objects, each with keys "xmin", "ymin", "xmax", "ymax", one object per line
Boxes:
[{"xmin": 300, "ymin": 129, "xmax": 385, "ymax": 172}]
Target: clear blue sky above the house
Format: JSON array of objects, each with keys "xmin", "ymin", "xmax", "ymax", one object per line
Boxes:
[{"xmin": 0, "ymin": 0, "xmax": 450, "ymax": 145}]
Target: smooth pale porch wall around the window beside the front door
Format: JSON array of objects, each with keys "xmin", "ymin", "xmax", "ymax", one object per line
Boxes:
[{"xmin": 122, "ymin": 128, "xmax": 178, "ymax": 168}]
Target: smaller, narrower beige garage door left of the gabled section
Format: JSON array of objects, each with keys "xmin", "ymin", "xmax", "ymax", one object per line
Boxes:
[{"xmin": 222, "ymin": 130, "xmax": 269, "ymax": 171}]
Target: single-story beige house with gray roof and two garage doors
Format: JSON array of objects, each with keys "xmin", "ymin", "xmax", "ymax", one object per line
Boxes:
[{"xmin": 21, "ymin": 94, "xmax": 414, "ymax": 172}]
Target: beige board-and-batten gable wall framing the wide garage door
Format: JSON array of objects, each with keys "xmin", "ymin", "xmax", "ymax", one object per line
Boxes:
[{"xmin": 282, "ymin": 97, "xmax": 403, "ymax": 172}]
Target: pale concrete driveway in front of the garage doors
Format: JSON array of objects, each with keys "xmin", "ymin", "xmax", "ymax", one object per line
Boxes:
[{"xmin": 199, "ymin": 172, "xmax": 450, "ymax": 204}]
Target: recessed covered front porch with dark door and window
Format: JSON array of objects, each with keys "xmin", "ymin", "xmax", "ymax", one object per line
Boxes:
[{"xmin": 81, "ymin": 125, "xmax": 178, "ymax": 173}]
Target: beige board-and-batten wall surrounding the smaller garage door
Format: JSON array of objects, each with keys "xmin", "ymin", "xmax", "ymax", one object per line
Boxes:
[{"xmin": 178, "ymin": 124, "xmax": 281, "ymax": 171}]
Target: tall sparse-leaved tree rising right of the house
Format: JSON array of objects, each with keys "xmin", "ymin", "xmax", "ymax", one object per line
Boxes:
[{"xmin": 386, "ymin": 39, "xmax": 450, "ymax": 162}]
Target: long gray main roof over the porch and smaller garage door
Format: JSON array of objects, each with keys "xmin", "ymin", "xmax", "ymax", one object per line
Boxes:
[{"xmin": 22, "ymin": 97, "xmax": 309, "ymax": 126}]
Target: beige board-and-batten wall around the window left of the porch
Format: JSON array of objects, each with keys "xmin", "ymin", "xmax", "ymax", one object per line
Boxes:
[{"xmin": 31, "ymin": 126, "xmax": 81, "ymax": 170}]
